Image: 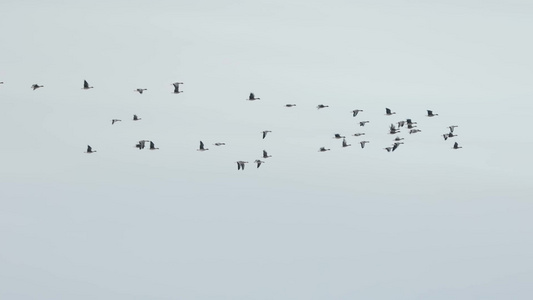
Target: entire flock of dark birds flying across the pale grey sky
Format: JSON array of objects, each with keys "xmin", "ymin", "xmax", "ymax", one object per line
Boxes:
[{"xmin": 0, "ymin": 80, "xmax": 462, "ymax": 170}]
